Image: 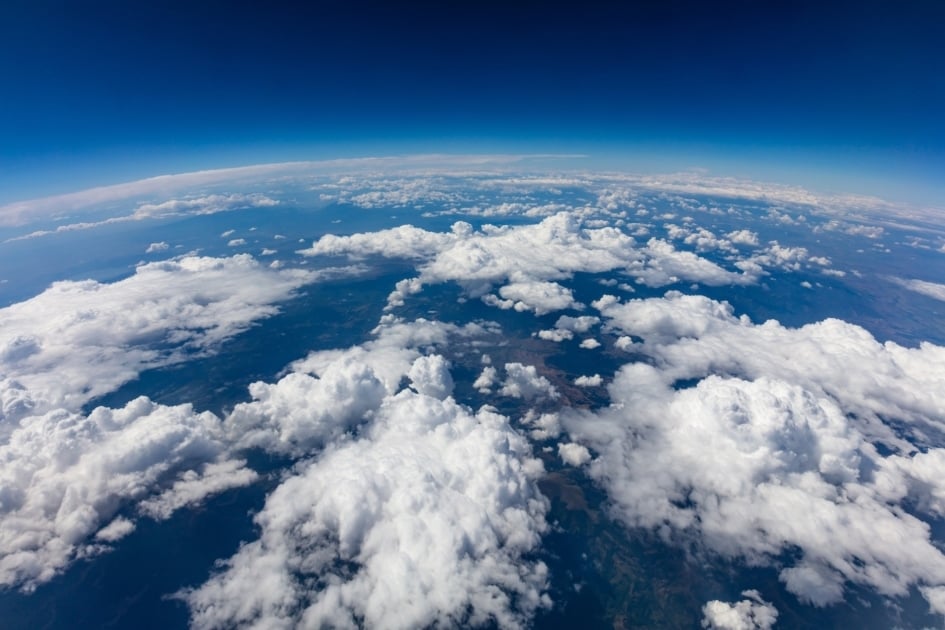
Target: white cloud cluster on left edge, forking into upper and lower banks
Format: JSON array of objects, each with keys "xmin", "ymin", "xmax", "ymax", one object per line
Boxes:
[{"xmin": 0, "ymin": 256, "xmax": 338, "ymax": 589}]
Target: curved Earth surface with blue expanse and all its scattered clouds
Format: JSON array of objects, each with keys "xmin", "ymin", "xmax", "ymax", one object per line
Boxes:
[{"xmin": 0, "ymin": 158, "xmax": 945, "ymax": 628}]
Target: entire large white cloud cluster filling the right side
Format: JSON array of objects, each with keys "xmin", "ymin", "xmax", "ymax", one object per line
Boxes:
[{"xmin": 563, "ymin": 292, "xmax": 945, "ymax": 612}]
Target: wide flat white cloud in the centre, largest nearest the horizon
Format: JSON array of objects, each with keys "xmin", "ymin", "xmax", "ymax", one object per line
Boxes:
[{"xmin": 300, "ymin": 212, "xmax": 758, "ymax": 310}]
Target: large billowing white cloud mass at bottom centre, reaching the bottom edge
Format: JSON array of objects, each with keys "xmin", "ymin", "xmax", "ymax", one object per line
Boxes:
[{"xmin": 181, "ymin": 390, "xmax": 550, "ymax": 628}]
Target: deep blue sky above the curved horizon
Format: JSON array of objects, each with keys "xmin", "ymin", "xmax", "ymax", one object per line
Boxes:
[{"xmin": 0, "ymin": 0, "xmax": 945, "ymax": 206}]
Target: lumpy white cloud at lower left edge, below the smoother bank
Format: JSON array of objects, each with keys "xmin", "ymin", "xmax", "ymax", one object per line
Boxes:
[{"xmin": 0, "ymin": 398, "xmax": 224, "ymax": 589}]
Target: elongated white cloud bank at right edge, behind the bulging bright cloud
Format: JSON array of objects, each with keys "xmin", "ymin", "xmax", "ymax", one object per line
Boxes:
[{"xmin": 594, "ymin": 292, "xmax": 945, "ymax": 444}]
